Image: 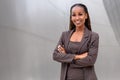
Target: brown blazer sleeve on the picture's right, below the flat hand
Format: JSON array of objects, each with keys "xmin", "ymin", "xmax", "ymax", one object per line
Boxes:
[{"xmin": 74, "ymin": 32, "xmax": 99, "ymax": 67}]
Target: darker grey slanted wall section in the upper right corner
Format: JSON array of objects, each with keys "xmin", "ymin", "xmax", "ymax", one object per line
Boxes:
[{"xmin": 103, "ymin": 0, "xmax": 120, "ymax": 44}]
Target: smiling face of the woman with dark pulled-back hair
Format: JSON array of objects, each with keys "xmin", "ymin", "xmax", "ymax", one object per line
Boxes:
[{"xmin": 71, "ymin": 6, "xmax": 87, "ymax": 27}]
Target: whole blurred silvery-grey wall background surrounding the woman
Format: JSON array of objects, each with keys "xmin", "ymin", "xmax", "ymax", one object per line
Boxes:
[{"xmin": 0, "ymin": 0, "xmax": 120, "ymax": 80}]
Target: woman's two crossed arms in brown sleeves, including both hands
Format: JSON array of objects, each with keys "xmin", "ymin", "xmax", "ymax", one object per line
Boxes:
[{"xmin": 53, "ymin": 31, "xmax": 99, "ymax": 67}]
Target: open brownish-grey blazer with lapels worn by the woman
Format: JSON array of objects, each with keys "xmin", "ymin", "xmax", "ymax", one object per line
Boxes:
[{"xmin": 53, "ymin": 28, "xmax": 99, "ymax": 80}]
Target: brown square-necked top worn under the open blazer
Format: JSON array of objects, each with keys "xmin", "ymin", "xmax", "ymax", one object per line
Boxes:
[{"xmin": 67, "ymin": 41, "xmax": 84, "ymax": 80}]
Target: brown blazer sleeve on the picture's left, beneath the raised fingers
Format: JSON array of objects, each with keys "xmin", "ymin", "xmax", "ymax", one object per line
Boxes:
[{"xmin": 53, "ymin": 32, "xmax": 75, "ymax": 63}]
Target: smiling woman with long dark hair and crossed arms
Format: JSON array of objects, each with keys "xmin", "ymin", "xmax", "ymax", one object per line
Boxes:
[{"xmin": 53, "ymin": 4, "xmax": 99, "ymax": 80}]
